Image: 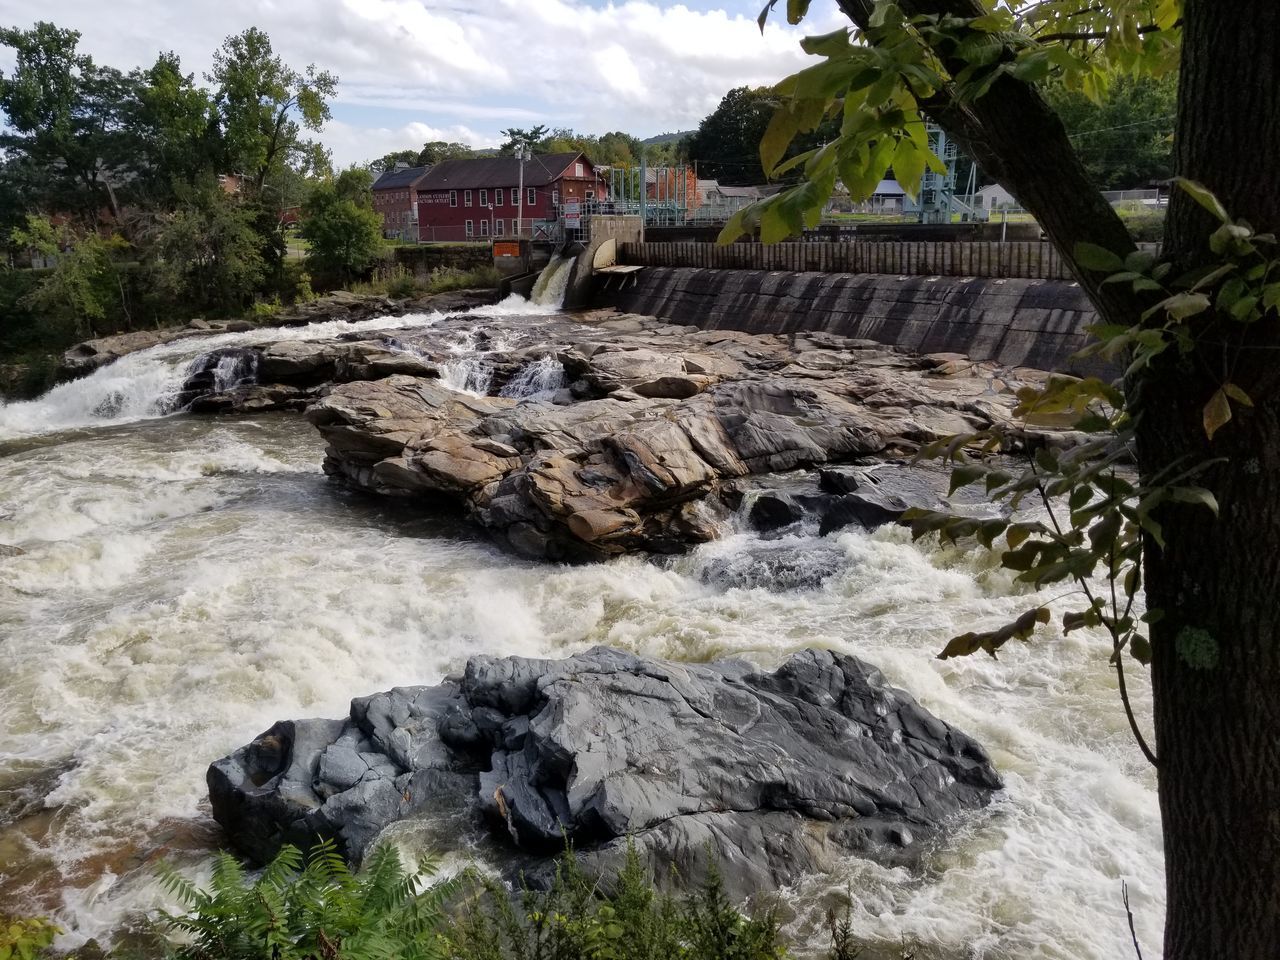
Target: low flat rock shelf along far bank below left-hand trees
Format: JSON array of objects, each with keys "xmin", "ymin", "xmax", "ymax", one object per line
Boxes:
[{"xmin": 58, "ymin": 291, "xmax": 495, "ymax": 380}]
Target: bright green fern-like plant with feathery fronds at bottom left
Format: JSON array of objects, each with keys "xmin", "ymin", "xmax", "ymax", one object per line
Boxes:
[{"xmin": 161, "ymin": 841, "xmax": 456, "ymax": 960}]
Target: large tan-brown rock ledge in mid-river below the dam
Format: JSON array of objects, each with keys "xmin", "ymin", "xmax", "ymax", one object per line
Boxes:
[{"xmin": 293, "ymin": 316, "xmax": 1064, "ymax": 561}]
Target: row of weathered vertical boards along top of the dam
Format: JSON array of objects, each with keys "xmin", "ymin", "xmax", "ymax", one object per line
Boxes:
[{"xmin": 618, "ymin": 241, "xmax": 1156, "ymax": 280}]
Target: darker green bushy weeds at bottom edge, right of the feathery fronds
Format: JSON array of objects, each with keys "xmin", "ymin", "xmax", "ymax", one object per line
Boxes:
[{"xmin": 444, "ymin": 847, "xmax": 786, "ymax": 960}]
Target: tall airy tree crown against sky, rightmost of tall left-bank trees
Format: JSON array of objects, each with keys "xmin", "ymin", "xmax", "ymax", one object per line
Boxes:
[{"xmin": 207, "ymin": 27, "xmax": 338, "ymax": 192}]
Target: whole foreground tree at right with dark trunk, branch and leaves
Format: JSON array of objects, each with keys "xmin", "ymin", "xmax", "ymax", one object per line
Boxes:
[{"xmin": 742, "ymin": 0, "xmax": 1280, "ymax": 960}]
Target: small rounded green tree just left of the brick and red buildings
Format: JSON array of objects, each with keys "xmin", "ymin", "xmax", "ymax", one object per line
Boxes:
[{"xmin": 302, "ymin": 166, "xmax": 383, "ymax": 284}]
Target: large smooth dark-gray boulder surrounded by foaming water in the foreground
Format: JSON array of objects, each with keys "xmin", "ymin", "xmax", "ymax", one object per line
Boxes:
[{"xmin": 209, "ymin": 648, "xmax": 1001, "ymax": 895}]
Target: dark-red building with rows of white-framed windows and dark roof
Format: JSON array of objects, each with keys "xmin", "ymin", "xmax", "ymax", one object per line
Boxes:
[{"xmin": 414, "ymin": 154, "xmax": 608, "ymax": 242}]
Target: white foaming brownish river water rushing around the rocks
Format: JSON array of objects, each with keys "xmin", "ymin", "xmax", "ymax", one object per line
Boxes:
[{"xmin": 0, "ymin": 296, "xmax": 1164, "ymax": 960}]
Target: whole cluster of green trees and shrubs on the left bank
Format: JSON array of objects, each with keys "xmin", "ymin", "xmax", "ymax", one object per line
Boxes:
[{"xmin": 0, "ymin": 23, "xmax": 383, "ymax": 353}]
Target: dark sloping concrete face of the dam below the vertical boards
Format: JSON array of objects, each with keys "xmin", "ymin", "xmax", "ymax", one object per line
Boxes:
[{"xmin": 595, "ymin": 271, "xmax": 1115, "ymax": 375}]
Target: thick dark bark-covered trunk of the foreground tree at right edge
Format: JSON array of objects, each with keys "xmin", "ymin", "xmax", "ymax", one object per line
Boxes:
[{"xmin": 1137, "ymin": 0, "xmax": 1280, "ymax": 960}]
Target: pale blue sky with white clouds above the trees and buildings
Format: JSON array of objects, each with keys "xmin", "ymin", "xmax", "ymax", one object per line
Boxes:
[{"xmin": 0, "ymin": 0, "xmax": 842, "ymax": 165}]
